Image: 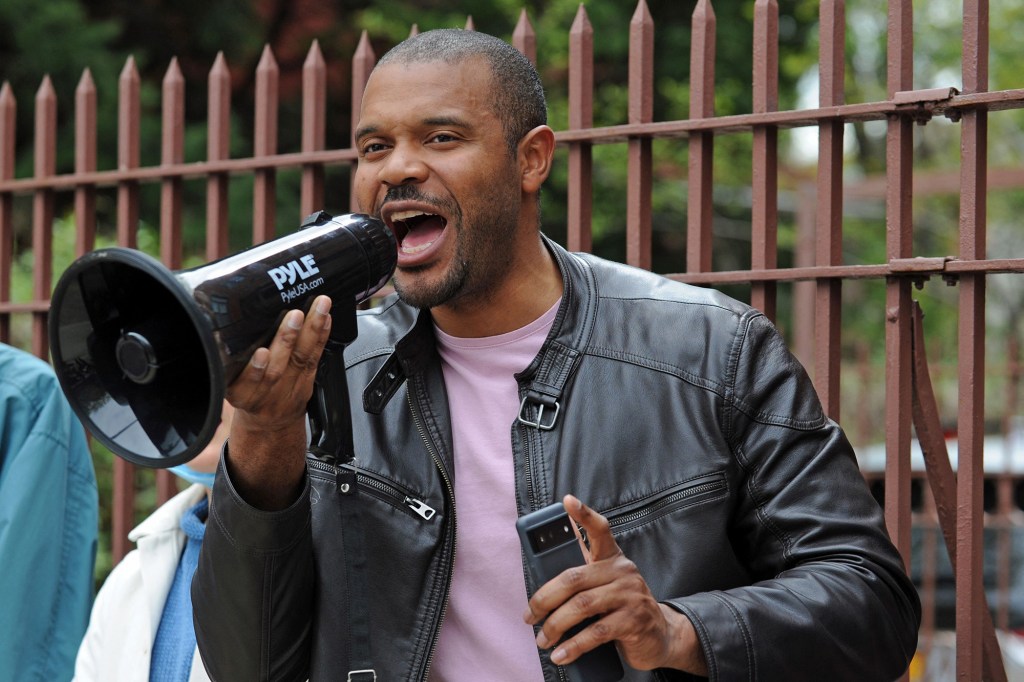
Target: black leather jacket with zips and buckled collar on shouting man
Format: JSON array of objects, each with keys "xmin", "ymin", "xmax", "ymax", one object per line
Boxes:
[{"xmin": 193, "ymin": 236, "xmax": 920, "ymax": 682}]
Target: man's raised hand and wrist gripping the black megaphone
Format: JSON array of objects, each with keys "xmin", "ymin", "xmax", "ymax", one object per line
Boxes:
[{"xmin": 227, "ymin": 296, "xmax": 331, "ymax": 510}]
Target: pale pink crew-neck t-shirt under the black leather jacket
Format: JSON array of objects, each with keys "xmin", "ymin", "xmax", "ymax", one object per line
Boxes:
[{"xmin": 430, "ymin": 303, "xmax": 558, "ymax": 682}]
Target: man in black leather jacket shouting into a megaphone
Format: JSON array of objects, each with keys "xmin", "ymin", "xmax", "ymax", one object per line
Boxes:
[{"xmin": 194, "ymin": 31, "xmax": 920, "ymax": 680}]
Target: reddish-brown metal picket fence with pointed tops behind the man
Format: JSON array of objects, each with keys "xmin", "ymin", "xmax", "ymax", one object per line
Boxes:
[{"xmin": 0, "ymin": 0, "xmax": 1024, "ymax": 680}]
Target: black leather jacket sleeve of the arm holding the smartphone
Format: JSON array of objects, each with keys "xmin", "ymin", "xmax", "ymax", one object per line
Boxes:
[{"xmin": 669, "ymin": 313, "xmax": 921, "ymax": 682}]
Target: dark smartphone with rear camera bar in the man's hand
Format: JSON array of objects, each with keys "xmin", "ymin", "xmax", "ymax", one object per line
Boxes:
[{"xmin": 515, "ymin": 502, "xmax": 624, "ymax": 682}]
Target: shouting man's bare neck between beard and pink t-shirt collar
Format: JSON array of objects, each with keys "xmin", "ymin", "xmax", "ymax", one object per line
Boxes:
[{"xmin": 430, "ymin": 235, "xmax": 562, "ymax": 338}]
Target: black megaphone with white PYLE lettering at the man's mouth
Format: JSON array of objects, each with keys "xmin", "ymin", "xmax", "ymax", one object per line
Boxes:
[{"xmin": 49, "ymin": 211, "xmax": 397, "ymax": 468}]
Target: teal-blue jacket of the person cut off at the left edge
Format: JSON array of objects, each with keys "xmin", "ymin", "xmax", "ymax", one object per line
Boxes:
[{"xmin": 0, "ymin": 343, "xmax": 99, "ymax": 682}]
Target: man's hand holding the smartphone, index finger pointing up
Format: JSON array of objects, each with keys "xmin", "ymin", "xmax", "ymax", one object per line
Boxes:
[{"xmin": 523, "ymin": 495, "xmax": 708, "ymax": 675}]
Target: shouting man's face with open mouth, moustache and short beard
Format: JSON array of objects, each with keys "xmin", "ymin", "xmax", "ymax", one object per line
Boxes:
[{"xmin": 354, "ymin": 58, "xmax": 522, "ymax": 308}]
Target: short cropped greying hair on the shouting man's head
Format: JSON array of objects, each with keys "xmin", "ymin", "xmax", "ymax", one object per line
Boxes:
[{"xmin": 377, "ymin": 29, "xmax": 548, "ymax": 154}]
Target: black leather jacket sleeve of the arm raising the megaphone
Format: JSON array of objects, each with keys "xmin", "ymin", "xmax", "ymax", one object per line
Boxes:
[{"xmin": 191, "ymin": 444, "xmax": 314, "ymax": 682}]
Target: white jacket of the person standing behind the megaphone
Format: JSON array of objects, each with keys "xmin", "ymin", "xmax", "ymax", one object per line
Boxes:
[{"xmin": 75, "ymin": 485, "xmax": 210, "ymax": 682}]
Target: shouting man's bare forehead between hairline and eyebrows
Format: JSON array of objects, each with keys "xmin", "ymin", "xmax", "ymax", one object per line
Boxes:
[{"xmin": 359, "ymin": 57, "xmax": 494, "ymax": 128}]
